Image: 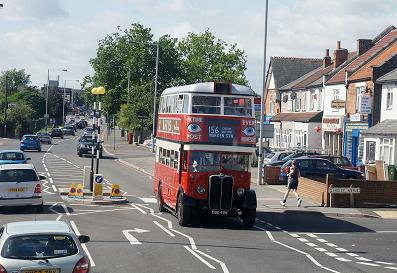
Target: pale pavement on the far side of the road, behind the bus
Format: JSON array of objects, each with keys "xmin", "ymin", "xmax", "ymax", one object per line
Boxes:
[{"xmin": 102, "ymin": 128, "xmax": 388, "ymax": 219}]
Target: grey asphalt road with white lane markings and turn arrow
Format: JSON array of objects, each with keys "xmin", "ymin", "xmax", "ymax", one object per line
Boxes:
[{"xmin": 0, "ymin": 134, "xmax": 397, "ymax": 273}]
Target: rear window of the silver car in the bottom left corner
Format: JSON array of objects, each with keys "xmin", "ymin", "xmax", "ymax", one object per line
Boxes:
[{"xmin": 1, "ymin": 234, "xmax": 78, "ymax": 260}]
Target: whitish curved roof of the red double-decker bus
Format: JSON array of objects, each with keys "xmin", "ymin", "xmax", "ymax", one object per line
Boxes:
[{"xmin": 162, "ymin": 82, "xmax": 255, "ymax": 96}]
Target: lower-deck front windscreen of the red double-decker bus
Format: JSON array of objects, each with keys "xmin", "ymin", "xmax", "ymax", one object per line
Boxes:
[{"xmin": 189, "ymin": 151, "xmax": 249, "ymax": 172}]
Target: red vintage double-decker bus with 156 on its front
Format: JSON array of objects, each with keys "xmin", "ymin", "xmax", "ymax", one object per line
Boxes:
[{"xmin": 154, "ymin": 82, "xmax": 257, "ymax": 227}]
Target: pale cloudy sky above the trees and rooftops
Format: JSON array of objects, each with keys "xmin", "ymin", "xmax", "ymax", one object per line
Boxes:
[{"xmin": 0, "ymin": 0, "xmax": 397, "ymax": 93}]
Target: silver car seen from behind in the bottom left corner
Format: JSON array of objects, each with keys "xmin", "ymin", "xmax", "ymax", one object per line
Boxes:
[{"xmin": 0, "ymin": 221, "xmax": 90, "ymax": 273}]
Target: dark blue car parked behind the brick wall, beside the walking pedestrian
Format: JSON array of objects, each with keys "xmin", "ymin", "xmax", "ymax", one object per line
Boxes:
[{"xmin": 279, "ymin": 157, "xmax": 364, "ymax": 183}]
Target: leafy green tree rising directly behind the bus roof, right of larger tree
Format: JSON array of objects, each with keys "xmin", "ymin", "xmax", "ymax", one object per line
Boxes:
[{"xmin": 178, "ymin": 29, "xmax": 248, "ymax": 85}]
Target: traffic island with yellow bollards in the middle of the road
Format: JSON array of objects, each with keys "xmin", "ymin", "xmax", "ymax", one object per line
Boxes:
[{"xmin": 59, "ymin": 188, "xmax": 128, "ymax": 205}]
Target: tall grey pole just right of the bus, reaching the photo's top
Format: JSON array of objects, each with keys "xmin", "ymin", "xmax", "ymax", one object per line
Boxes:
[{"xmin": 258, "ymin": 0, "xmax": 269, "ymax": 185}]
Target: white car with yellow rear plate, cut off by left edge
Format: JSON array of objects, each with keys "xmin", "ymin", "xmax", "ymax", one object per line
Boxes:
[{"xmin": 0, "ymin": 164, "xmax": 46, "ymax": 212}]
